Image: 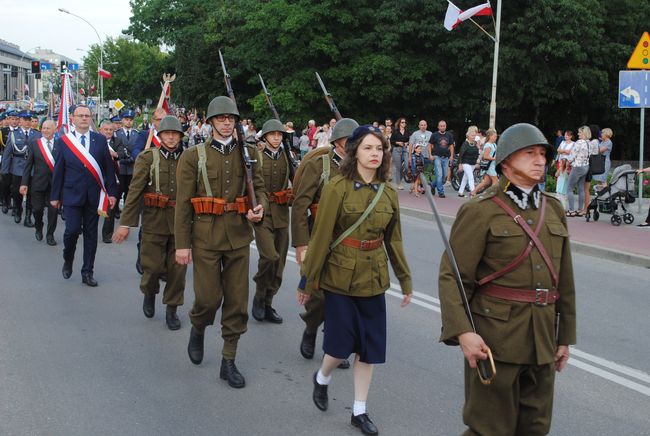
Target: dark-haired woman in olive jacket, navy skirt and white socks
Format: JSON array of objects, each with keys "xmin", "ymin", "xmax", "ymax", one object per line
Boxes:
[{"xmin": 298, "ymin": 126, "xmax": 412, "ymax": 435}]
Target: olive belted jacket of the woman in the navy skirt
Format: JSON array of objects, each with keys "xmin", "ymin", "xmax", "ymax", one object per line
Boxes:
[{"xmin": 302, "ymin": 175, "xmax": 413, "ymax": 297}]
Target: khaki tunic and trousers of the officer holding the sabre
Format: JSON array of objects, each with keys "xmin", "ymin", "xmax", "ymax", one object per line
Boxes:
[{"xmin": 438, "ymin": 177, "xmax": 576, "ymax": 435}]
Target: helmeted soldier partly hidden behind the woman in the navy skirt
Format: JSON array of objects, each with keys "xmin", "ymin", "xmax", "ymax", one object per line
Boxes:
[{"xmin": 291, "ymin": 118, "xmax": 359, "ymax": 368}]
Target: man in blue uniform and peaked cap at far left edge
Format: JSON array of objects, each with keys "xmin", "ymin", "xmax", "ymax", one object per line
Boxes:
[{"xmin": 0, "ymin": 112, "xmax": 41, "ymax": 227}]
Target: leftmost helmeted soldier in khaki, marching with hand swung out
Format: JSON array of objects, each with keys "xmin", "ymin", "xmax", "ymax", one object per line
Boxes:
[{"xmin": 113, "ymin": 115, "xmax": 187, "ymax": 330}]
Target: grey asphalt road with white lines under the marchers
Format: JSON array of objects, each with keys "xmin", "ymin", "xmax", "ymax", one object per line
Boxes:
[{"xmin": 0, "ymin": 210, "xmax": 650, "ymax": 435}]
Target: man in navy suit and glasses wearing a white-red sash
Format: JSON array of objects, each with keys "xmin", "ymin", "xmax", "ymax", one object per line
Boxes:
[{"xmin": 51, "ymin": 106, "xmax": 117, "ymax": 286}]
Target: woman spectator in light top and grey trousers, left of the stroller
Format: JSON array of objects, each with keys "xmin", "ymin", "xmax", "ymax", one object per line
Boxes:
[{"xmin": 566, "ymin": 126, "xmax": 595, "ymax": 217}]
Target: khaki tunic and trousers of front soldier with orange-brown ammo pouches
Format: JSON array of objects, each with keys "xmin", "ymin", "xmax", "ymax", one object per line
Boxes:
[{"xmin": 175, "ymin": 142, "xmax": 268, "ymax": 359}]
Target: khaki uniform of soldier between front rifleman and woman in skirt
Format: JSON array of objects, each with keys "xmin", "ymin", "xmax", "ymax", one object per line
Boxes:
[{"xmin": 253, "ymin": 149, "xmax": 289, "ymax": 306}]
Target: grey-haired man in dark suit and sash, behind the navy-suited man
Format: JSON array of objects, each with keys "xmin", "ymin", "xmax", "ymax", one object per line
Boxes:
[{"xmin": 20, "ymin": 120, "xmax": 58, "ymax": 245}]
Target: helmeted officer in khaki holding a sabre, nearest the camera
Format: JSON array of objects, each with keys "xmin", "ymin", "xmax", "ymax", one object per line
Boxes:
[{"xmin": 438, "ymin": 124, "xmax": 576, "ymax": 436}]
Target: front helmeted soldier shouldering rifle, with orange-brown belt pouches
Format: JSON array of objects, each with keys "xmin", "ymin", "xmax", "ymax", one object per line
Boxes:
[{"xmin": 175, "ymin": 96, "xmax": 268, "ymax": 388}]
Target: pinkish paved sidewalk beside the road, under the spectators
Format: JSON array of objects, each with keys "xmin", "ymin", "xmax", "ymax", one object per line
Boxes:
[{"xmin": 399, "ymin": 185, "xmax": 650, "ymax": 268}]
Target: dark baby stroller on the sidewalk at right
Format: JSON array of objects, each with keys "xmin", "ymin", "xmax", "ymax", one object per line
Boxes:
[{"xmin": 585, "ymin": 164, "xmax": 636, "ymax": 226}]
